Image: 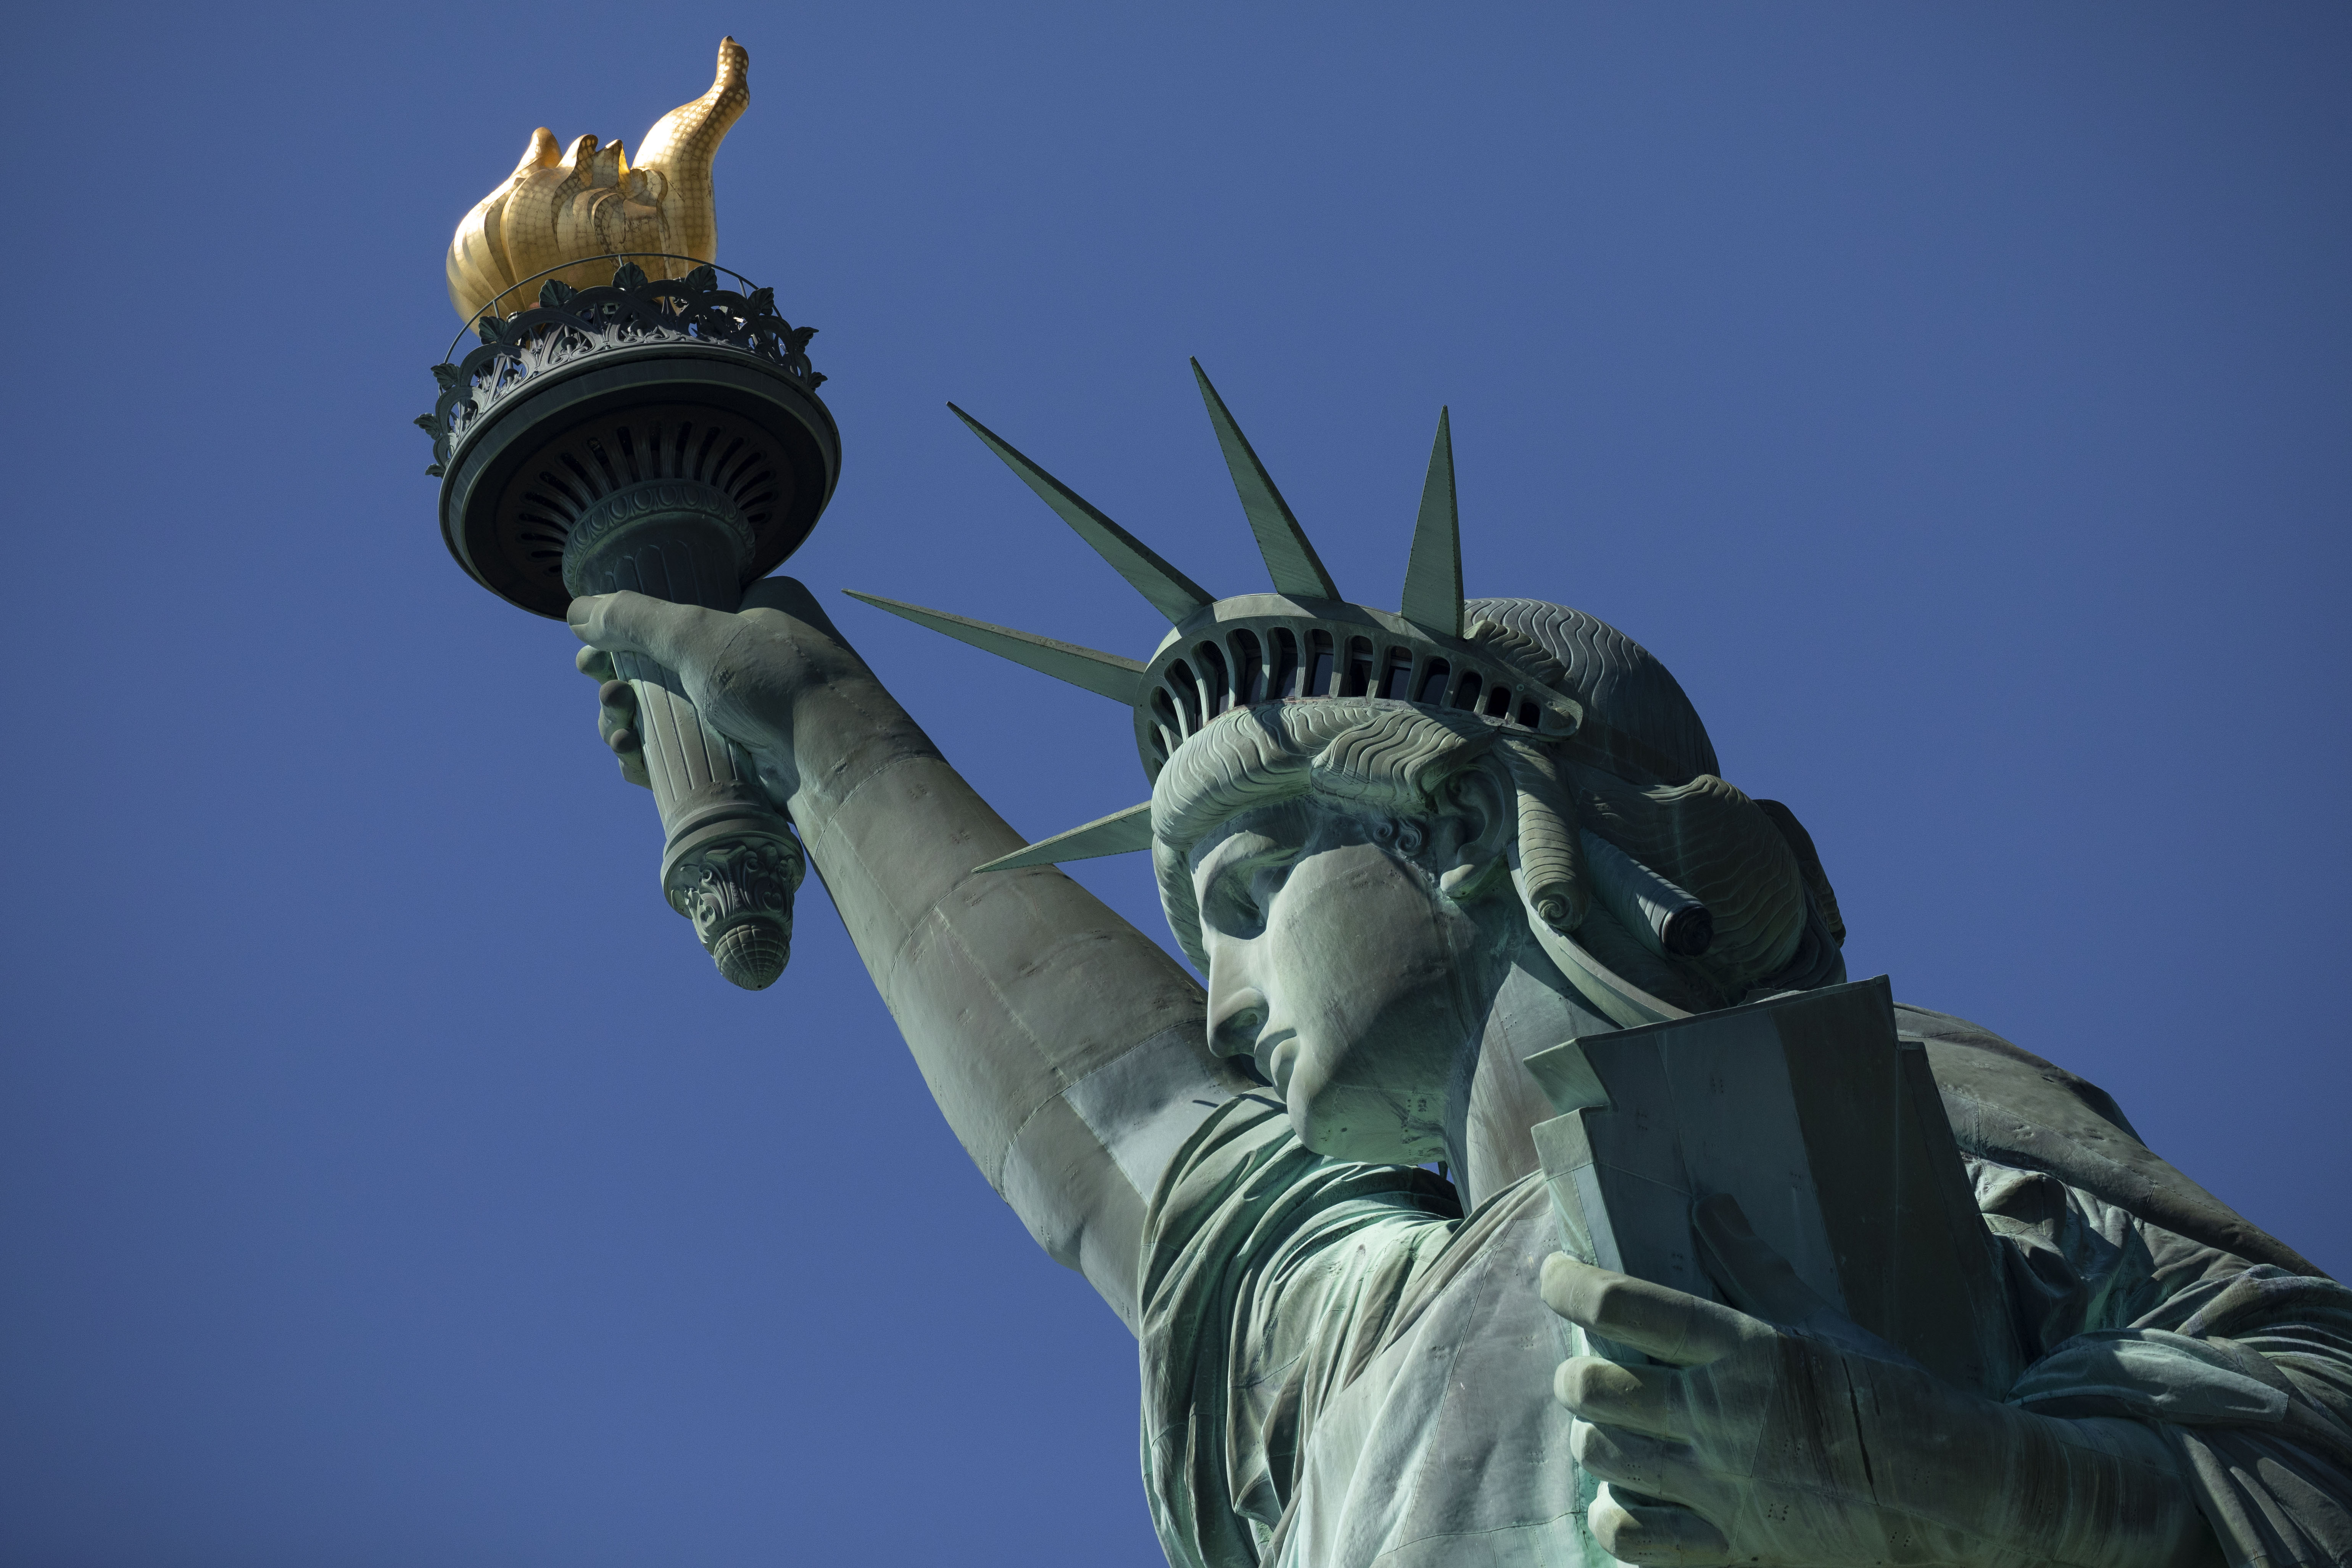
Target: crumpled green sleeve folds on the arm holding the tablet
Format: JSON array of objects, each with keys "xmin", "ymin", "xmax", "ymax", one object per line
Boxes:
[{"xmin": 1978, "ymin": 1171, "xmax": 2352, "ymax": 1568}]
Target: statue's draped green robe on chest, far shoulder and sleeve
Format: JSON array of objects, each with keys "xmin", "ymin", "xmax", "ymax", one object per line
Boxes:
[{"xmin": 1141, "ymin": 1006, "xmax": 2352, "ymax": 1568}]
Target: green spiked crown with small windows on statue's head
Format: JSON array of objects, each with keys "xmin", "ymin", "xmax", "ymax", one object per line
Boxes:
[{"xmin": 851, "ymin": 360, "xmax": 1715, "ymax": 870}]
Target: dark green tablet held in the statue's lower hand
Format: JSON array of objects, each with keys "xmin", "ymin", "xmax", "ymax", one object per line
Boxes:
[{"xmin": 1526, "ymin": 976, "xmax": 2020, "ymax": 1399}]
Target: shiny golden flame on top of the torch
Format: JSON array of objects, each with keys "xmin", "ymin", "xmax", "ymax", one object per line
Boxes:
[{"xmin": 449, "ymin": 38, "xmax": 750, "ymax": 322}]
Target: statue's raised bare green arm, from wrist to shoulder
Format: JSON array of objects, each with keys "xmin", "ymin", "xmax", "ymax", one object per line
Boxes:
[{"xmin": 776, "ymin": 625, "xmax": 1247, "ymax": 1328}]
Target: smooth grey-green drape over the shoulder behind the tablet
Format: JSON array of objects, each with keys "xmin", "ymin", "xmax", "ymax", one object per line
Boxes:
[{"xmin": 1896, "ymin": 1004, "xmax": 2319, "ymax": 1274}]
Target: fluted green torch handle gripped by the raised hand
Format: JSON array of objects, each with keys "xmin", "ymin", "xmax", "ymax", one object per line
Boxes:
[{"xmin": 564, "ymin": 508, "xmax": 807, "ymax": 990}]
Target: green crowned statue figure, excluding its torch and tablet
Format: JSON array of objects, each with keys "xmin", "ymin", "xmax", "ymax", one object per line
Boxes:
[{"xmin": 569, "ymin": 364, "xmax": 2352, "ymax": 1568}]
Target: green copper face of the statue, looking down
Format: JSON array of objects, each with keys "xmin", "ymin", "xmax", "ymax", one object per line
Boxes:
[{"xmin": 1192, "ymin": 799, "xmax": 1496, "ymax": 1164}]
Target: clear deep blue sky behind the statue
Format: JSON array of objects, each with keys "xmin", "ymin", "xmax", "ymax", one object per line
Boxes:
[{"xmin": 0, "ymin": 0, "xmax": 2352, "ymax": 1568}]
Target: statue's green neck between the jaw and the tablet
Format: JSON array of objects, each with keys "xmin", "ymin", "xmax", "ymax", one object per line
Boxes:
[{"xmin": 1447, "ymin": 940, "xmax": 1616, "ymax": 1208}]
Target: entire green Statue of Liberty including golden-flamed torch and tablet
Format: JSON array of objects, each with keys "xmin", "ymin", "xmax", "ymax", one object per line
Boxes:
[{"xmin": 433, "ymin": 40, "xmax": 2352, "ymax": 1568}]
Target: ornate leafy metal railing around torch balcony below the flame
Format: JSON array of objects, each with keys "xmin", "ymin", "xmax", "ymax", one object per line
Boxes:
[{"xmin": 416, "ymin": 251, "xmax": 826, "ymax": 475}]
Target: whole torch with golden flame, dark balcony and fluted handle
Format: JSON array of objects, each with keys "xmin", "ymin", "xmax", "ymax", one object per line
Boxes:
[{"xmin": 416, "ymin": 38, "xmax": 840, "ymax": 990}]
